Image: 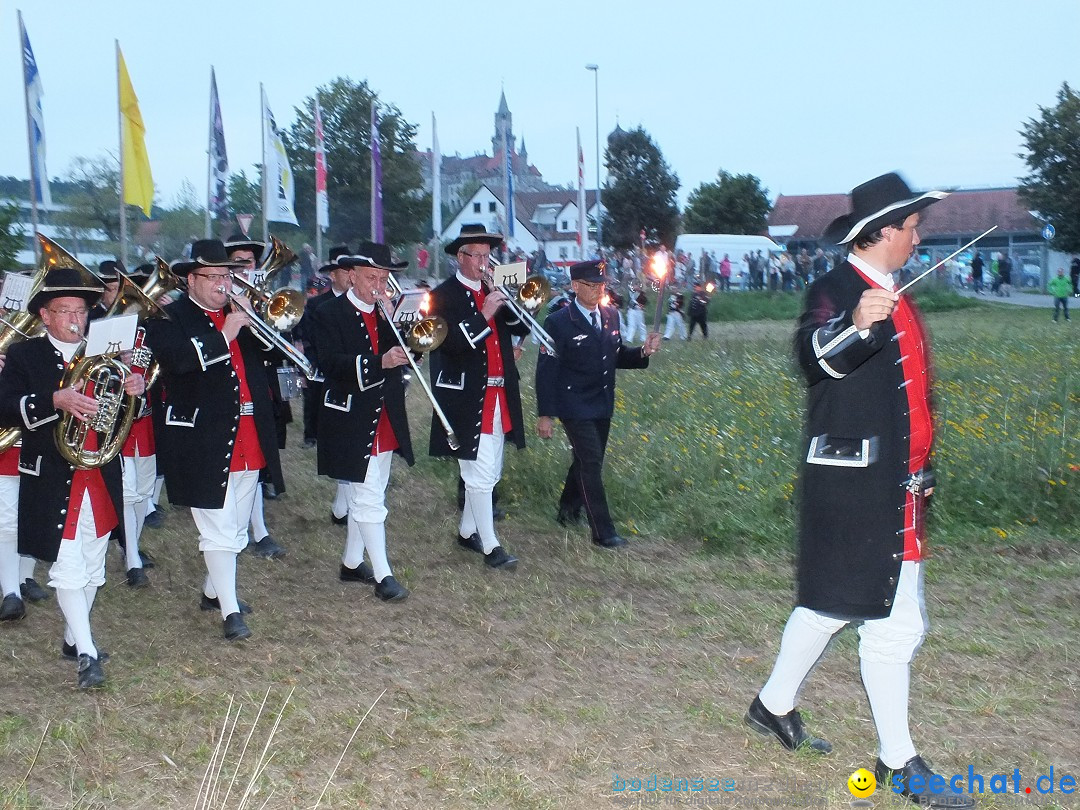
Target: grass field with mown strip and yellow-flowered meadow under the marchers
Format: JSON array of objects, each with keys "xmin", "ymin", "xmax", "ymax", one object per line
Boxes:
[{"xmin": 0, "ymin": 306, "xmax": 1080, "ymax": 810}]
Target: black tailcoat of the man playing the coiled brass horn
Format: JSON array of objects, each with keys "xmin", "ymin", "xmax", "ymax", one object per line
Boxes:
[{"xmin": 0, "ymin": 337, "xmax": 124, "ymax": 563}]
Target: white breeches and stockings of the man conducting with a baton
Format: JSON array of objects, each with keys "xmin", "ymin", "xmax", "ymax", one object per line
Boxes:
[{"xmin": 760, "ymin": 562, "xmax": 929, "ymax": 768}]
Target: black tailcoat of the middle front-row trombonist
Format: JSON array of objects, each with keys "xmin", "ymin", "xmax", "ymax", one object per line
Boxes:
[{"xmin": 309, "ymin": 295, "xmax": 413, "ymax": 482}]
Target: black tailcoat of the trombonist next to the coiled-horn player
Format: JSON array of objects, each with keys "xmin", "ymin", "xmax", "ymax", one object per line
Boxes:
[{"xmin": 147, "ymin": 296, "xmax": 285, "ymax": 509}]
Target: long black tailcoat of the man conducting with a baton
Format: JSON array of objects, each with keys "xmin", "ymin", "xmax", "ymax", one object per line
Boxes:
[{"xmin": 795, "ymin": 261, "xmax": 928, "ymax": 619}]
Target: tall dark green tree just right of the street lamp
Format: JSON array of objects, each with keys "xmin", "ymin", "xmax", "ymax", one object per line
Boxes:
[{"xmin": 603, "ymin": 126, "xmax": 679, "ymax": 247}]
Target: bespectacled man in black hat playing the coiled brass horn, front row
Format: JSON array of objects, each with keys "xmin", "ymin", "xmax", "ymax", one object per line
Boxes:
[{"xmin": 0, "ymin": 259, "xmax": 144, "ymax": 688}]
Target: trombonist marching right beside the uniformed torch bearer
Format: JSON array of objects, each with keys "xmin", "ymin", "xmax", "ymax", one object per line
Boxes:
[{"xmin": 431, "ymin": 225, "xmax": 530, "ymax": 570}]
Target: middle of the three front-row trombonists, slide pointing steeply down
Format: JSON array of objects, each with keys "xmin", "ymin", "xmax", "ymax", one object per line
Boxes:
[{"xmin": 309, "ymin": 242, "xmax": 413, "ymax": 602}]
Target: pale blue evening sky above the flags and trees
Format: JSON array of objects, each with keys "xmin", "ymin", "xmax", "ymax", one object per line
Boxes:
[{"xmin": 0, "ymin": 0, "xmax": 1080, "ymax": 216}]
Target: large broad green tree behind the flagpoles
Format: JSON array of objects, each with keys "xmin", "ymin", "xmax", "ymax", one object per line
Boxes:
[{"xmin": 283, "ymin": 77, "xmax": 431, "ymax": 245}]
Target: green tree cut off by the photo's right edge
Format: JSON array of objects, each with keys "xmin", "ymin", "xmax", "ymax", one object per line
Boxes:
[{"xmin": 1020, "ymin": 82, "xmax": 1080, "ymax": 253}]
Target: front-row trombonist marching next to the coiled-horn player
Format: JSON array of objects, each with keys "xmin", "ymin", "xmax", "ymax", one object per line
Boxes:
[{"xmin": 147, "ymin": 239, "xmax": 278, "ymax": 642}]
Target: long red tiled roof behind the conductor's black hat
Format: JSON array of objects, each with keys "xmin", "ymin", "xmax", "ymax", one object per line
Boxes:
[{"xmin": 769, "ymin": 188, "xmax": 1042, "ymax": 240}]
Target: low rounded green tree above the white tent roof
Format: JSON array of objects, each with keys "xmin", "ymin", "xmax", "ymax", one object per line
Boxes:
[{"xmin": 683, "ymin": 168, "xmax": 769, "ymax": 233}]
